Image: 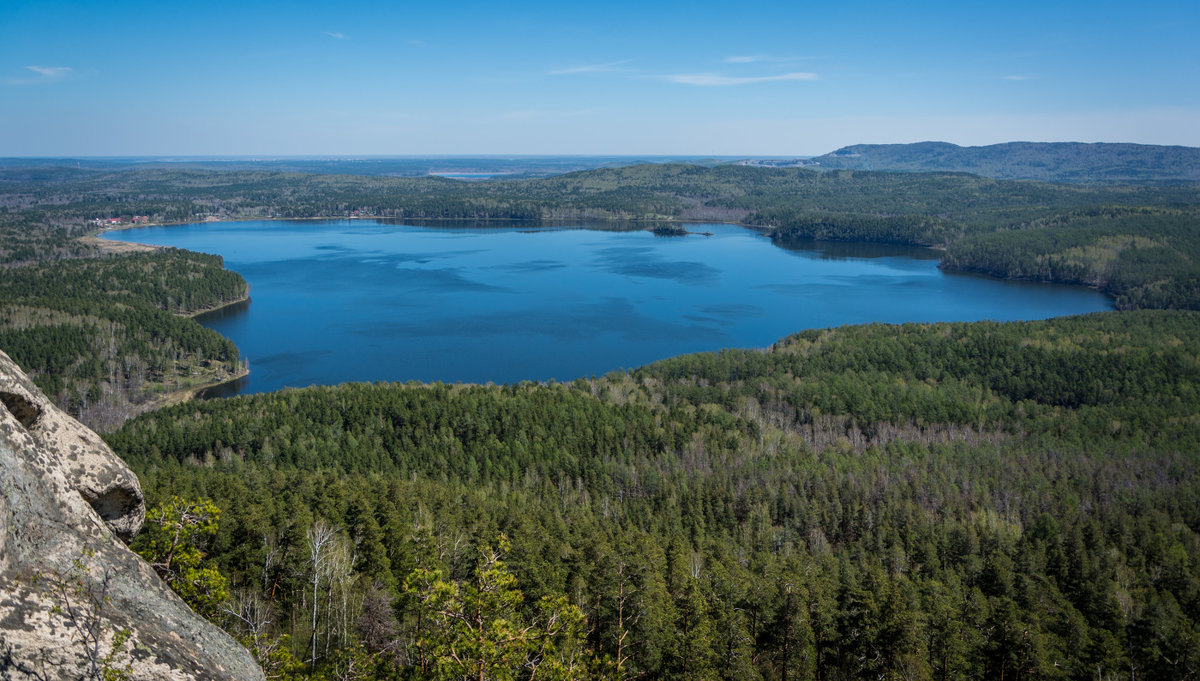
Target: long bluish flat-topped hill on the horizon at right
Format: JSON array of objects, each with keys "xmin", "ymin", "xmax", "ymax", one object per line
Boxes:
[{"xmin": 814, "ymin": 141, "xmax": 1200, "ymax": 182}]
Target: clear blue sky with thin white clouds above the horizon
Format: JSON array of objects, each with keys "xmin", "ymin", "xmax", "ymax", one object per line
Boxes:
[{"xmin": 0, "ymin": 0, "xmax": 1200, "ymax": 157}]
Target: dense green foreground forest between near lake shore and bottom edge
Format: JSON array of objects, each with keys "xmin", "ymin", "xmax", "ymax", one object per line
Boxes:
[{"xmin": 108, "ymin": 312, "xmax": 1200, "ymax": 680}]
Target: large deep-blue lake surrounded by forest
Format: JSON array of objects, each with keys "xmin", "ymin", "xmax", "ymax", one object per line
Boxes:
[{"xmin": 107, "ymin": 221, "xmax": 1112, "ymax": 392}]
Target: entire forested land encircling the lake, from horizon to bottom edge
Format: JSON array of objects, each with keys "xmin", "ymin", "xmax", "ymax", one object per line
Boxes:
[{"xmin": 0, "ymin": 158, "xmax": 1200, "ymax": 681}]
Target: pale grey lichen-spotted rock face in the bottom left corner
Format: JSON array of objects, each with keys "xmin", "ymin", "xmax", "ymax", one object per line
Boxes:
[{"xmin": 0, "ymin": 352, "xmax": 263, "ymax": 681}]
